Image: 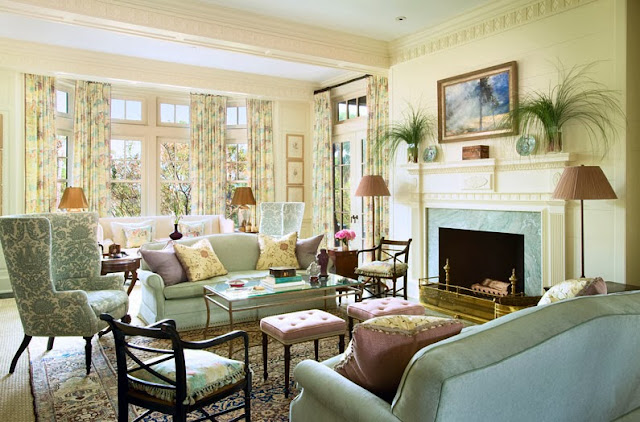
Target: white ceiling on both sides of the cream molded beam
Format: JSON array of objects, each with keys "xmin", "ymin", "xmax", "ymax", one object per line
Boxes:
[{"xmin": 0, "ymin": 0, "xmax": 496, "ymax": 85}]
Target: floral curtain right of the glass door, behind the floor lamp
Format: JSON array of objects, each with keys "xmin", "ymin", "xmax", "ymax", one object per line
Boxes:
[{"xmin": 364, "ymin": 76, "xmax": 389, "ymax": 247}]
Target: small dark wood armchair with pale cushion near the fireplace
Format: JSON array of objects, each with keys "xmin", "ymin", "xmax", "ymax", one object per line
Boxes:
[{"xmin": 355, "ymin": 237, "xmax": 412, "ymax": 300}]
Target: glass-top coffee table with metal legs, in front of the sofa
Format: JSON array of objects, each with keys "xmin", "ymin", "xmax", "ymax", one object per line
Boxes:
[{"xmin": 204, "ymin": 274, "xmax": 362, "ymax": 338}]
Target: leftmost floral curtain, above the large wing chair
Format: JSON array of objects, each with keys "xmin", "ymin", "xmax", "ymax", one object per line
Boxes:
[{"xmin": 24, "ymin": 74, "xmax": 57, "ymax": 213}]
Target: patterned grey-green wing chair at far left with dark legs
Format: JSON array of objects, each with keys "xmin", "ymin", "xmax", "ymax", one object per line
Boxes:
[{"xmin": 0, "ymin": 213, "xmax": 129, "ymax": 374}]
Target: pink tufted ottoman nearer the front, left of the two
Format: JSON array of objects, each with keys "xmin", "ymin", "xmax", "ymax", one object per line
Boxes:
[{"xmin": 260, "ymin": 309, "xmax": 347, "ymax": 397}]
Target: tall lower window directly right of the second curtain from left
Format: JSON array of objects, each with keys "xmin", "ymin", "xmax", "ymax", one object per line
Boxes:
[{"xmin": 110, "ymin": 139, "xmax": 142, "ymax": 217}]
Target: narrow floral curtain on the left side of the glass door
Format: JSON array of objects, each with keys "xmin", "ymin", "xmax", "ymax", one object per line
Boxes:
[{"xmin": 312, "ymin": 91, "xmax": 333, "ymax": 245}]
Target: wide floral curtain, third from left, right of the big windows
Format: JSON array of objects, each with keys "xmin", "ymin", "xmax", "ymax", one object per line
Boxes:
[{"xmin": 190, "ymin": 94, "xmax": 227, "ymax": 215}]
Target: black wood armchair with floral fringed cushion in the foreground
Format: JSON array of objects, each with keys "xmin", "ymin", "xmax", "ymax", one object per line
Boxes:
[{"xmin": 100, "ymin": 314, "xmax": 251, "ymax": 422}]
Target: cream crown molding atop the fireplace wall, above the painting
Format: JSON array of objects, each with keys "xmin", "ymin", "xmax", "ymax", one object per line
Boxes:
[{"xmin": 390, "ymin": 0, "xmax": 597, "ymax": 65}]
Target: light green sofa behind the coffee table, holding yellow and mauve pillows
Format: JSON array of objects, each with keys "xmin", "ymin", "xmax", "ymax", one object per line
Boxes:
[{"xmin": 138, "ymin": 233, "xmax": 335, "ymax": 330}]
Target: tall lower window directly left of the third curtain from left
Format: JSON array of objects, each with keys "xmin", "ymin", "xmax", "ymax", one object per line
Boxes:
[{"xmin": 159, "ymin": 140, "xmax": 191, "ymax": 215}]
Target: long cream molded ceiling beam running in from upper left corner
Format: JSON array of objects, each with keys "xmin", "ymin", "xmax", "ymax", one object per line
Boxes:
[{"xmin": 0, "ymin": 0, "xmax": 390, "ymax": 73}]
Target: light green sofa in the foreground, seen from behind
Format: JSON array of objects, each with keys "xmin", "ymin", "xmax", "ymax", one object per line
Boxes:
[{"xmin": 290, "ymin": 291, "xmax": 640, "ymax": 422}]
